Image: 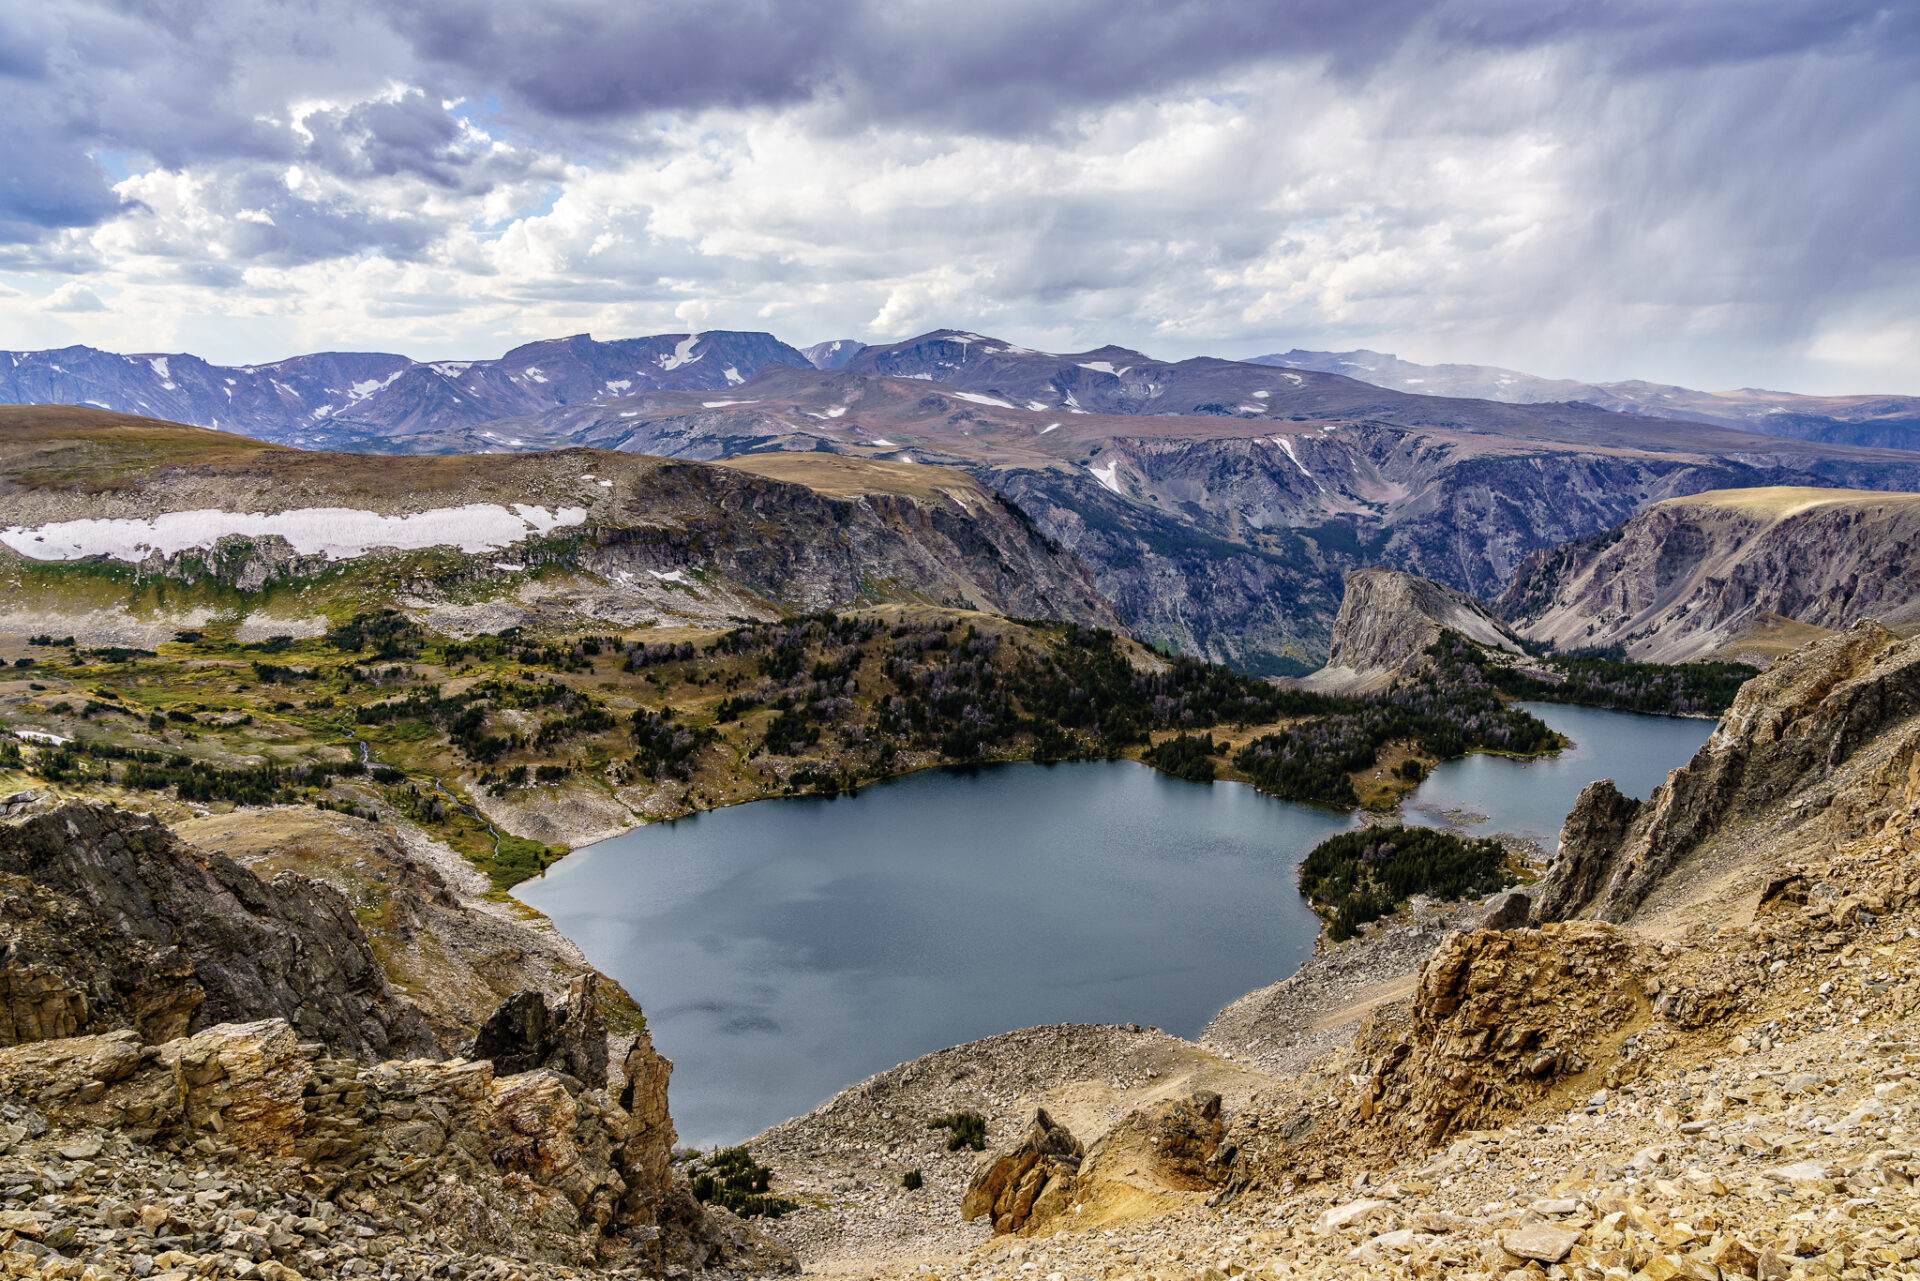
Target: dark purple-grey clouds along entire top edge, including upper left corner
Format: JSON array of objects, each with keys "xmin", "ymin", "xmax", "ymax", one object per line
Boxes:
[{"xmin": 0, "ymin": 0, "xmax": 1920, "ymax": 244}]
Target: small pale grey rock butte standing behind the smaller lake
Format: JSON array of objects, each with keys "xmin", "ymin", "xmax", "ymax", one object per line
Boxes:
[{"xmin": 1300, "ymin": 568, "xmax": 1524, "ymax": 693}]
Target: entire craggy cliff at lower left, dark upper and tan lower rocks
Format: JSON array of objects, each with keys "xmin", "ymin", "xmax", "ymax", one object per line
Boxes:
[{"xmin": 0, "ymin": 803, "xmax": 768, "ymax": 1275}]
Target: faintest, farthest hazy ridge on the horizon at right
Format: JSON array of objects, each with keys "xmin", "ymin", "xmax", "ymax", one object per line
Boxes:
[{"xmin": 1248, "ymin": 348, "xmax": 1920, "ymax": 449}]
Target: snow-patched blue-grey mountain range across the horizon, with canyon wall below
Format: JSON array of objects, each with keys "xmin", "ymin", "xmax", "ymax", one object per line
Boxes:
[{"xmin": 11, "ymin": 328, "xmax": 1920, "ymax": 672}]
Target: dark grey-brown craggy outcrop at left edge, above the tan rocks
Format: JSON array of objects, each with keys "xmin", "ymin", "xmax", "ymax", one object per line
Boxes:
[{"xmin": 0, "ymin": 803, "xmax": 438, "ymax": 1056}]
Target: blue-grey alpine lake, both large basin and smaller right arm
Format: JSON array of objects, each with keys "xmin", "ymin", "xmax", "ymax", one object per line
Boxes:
[{"xmin": 515, "ymin": 703, "xmax": 1715, "ymax": 1145}]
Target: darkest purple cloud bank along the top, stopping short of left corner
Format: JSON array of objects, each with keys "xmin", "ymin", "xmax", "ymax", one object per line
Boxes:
[{"xmin": 390, "ymin": 0, "xmax": 1916, "ymax": 133}]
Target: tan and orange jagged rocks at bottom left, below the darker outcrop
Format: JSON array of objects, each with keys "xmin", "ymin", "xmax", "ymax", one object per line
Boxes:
[{"xmin": 0, "ymin": 1020, "xmax": 764, "ymax": 1269}]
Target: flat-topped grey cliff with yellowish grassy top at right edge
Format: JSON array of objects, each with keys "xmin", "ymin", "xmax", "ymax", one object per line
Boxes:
[{"xmin": 1500, "ymin": 488, "xmax": 1920, "ymax": 663}]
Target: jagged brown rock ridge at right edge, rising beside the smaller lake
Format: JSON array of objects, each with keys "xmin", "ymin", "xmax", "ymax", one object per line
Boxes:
[{"xmin": 1534, "ymin": 622, "xmax": 1920, "ymax": 922}]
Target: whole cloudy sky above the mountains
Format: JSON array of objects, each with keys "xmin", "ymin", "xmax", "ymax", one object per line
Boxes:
[{"xmin": 0, "ymin": 0, "xmax": 1920, "ymax": 394}]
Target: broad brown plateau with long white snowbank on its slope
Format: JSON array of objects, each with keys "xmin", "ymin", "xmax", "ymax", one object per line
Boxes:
[{"xmin": 0, "ymin": 405, "xmax": 1119, "ymax": 633}]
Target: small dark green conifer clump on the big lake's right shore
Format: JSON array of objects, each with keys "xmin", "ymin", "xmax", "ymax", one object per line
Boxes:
[{"xmin": 1300, "ymin": 828, "xmax": 1513, "ymax": 943}]
